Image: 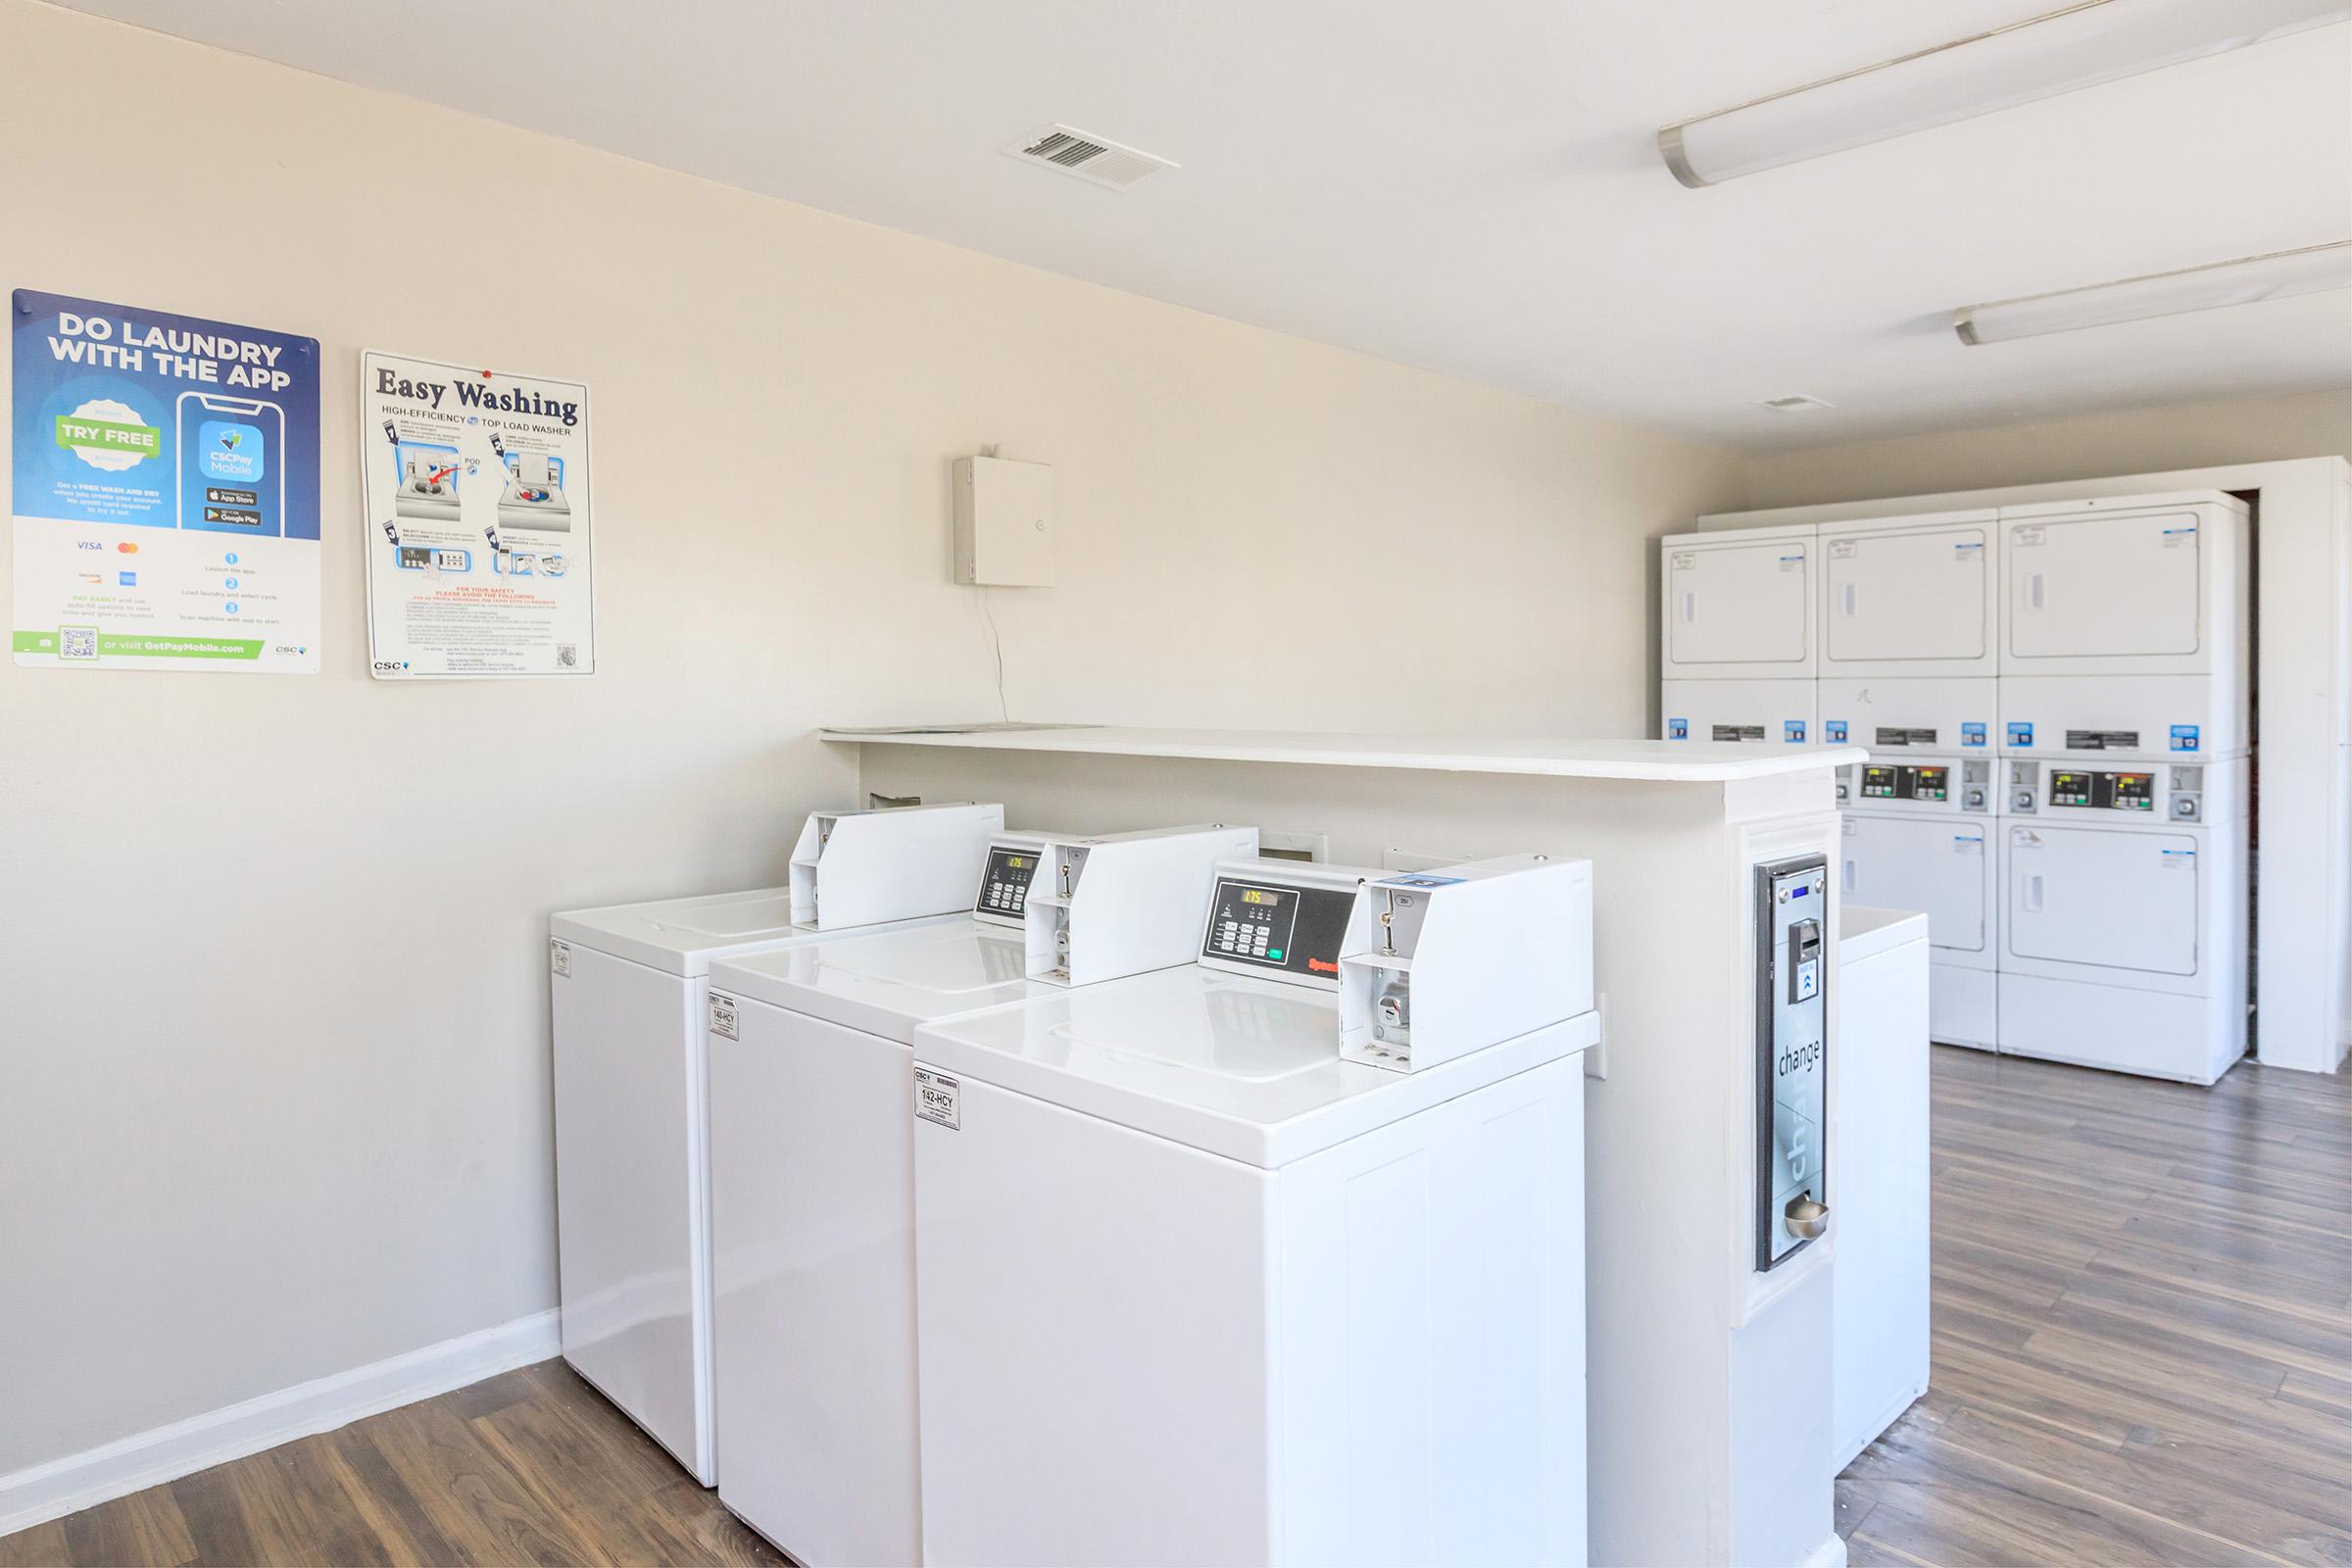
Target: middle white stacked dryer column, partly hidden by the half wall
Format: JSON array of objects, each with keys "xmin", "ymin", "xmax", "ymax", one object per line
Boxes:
[{"xmin": 1821, "ymin": 508, "xmax": 2001, "ymax": 1051}]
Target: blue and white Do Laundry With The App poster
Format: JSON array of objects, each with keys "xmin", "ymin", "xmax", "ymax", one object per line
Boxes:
[{"xmin": 10, "ymin": 289, "xmax": 319, "ymax": 674}]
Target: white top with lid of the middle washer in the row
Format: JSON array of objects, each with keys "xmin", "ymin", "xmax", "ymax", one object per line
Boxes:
[{"xmin": 710, "ymin": 914, "xmax": 1054, "ymax": 1044}]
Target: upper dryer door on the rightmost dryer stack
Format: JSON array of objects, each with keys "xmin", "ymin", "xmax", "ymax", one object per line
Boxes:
[{"xmin": 2004, "ymin": 511, "xmax": 2204, "ymax": 659}]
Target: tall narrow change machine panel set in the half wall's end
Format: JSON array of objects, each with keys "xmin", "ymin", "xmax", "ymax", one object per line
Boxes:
[{"xmin": 1754, "ymin": 856, "xmax": 1830, "ymax": 1272}]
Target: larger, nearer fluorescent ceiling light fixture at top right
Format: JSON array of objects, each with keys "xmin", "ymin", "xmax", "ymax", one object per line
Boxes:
[{"xmin": 1658, "ymin": 0, "xmax": 2352, "ymax": 188}]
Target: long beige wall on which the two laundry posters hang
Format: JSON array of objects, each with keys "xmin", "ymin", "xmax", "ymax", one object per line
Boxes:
[{"xmin": 0, "ymin": 0, "xmax": 1742, "ymax": 1476}]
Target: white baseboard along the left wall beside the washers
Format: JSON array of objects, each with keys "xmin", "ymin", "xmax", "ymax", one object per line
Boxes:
[{"xmin": 0, "ymin": 1307, "xmax": 563, "ymax": 1535}]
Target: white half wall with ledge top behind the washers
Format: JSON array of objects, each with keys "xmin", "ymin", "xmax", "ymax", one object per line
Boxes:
[{"xmin": 823, "ymin": 726, "xmax": 1863, "ymax": 1566}]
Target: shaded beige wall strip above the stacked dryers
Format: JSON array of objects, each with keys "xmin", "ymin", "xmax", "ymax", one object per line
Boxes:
[{"xmin": 1747, "ymin": 390, "xmax": 2352, "ymax": 508}]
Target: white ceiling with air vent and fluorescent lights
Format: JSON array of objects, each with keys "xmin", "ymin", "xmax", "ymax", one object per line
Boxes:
[{"xmin": 50, "ymin": 0, "xmax": 2352, "ymax": 447}]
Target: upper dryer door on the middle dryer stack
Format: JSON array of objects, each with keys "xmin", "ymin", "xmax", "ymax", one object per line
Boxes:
[{"xmin": 1821, "ymin": 526, "xmax": 1992, "ymax": 665}]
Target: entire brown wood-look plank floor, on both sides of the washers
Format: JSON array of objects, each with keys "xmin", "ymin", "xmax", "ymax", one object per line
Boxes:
[{"xmin": 0, "ymin": 1046, "xmax": 2352, "ymax": 1568}]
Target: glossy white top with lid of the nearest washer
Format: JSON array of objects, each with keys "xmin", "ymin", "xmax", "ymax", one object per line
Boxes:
[{"xmin": 915, "ymin": 966, "xmax": 1599, "ymax": 1168}]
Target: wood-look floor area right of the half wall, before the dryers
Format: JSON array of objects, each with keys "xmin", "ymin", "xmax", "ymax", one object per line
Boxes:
[{"xmin": 1837, "ymin": 1046, "xmax": 2352, "ymax": 1566}]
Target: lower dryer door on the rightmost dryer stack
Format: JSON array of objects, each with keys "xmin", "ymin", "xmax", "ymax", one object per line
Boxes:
[{"xmin": 2009, "ymin": 825, "xmax": 2204, "ymax": 976}]
